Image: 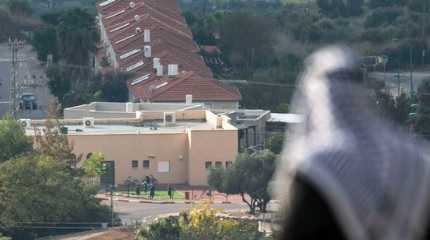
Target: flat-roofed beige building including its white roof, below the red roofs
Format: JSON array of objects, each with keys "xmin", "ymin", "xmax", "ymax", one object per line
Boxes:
[{"xmin": 26, "ymin": 103, "xmax": 238, "ymax": 186}]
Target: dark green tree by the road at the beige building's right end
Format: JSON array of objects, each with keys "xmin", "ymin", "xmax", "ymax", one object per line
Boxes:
[{"xmin": 208, "ymin": 150, "xmax": 276, "ymax": 213}]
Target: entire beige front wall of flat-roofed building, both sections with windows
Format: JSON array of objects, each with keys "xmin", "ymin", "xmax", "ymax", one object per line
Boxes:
[{"xmin": 68, "ymin": 126, "xmax": 238, "ymax": 186}]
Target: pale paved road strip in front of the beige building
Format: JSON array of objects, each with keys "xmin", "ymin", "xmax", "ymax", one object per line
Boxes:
[{"xmin": 103, "ymin": 201, "xmax": 246, "ymax": 224}]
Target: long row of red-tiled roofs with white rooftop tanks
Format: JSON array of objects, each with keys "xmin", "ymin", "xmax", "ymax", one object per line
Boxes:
[{"xmin": 97, "ymin": 0, "xmax": 241, "ymax": 108}]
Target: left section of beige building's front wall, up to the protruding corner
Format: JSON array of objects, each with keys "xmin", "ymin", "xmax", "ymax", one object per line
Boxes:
[{"xmin": 69, "ymin": 133, "xmax": 188, "ymax": 184}]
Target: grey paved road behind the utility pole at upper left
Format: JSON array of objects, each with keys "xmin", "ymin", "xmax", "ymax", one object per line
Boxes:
[{"xmin": 0, "ymin": 43, "xmax": 52, "ymax": 119}]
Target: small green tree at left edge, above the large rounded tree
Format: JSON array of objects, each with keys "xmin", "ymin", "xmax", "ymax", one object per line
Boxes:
[{"xmin": 0, "ymin": 116, "xmax": 32, "ymax": 164}]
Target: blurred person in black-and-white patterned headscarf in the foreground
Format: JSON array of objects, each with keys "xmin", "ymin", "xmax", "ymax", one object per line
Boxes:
[{"xmin": 275, "ymin": 47, "xmax": 430, "ymax": 240}]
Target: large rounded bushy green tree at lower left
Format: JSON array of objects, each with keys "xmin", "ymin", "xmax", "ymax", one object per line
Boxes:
[{"xmin": 0, "ymin": 154, "xmax": 109, "ymax": 229}]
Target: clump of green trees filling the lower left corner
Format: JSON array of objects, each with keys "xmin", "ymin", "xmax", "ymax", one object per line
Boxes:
[{"xmin": 0, "ymin": 118, "xmax": 111, "ymax": 239}]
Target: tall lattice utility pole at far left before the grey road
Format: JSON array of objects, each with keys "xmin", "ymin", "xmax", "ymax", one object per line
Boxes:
[{"xmin": 8, "ymin": 38, "xmax": 24, "ymax": 118}]
